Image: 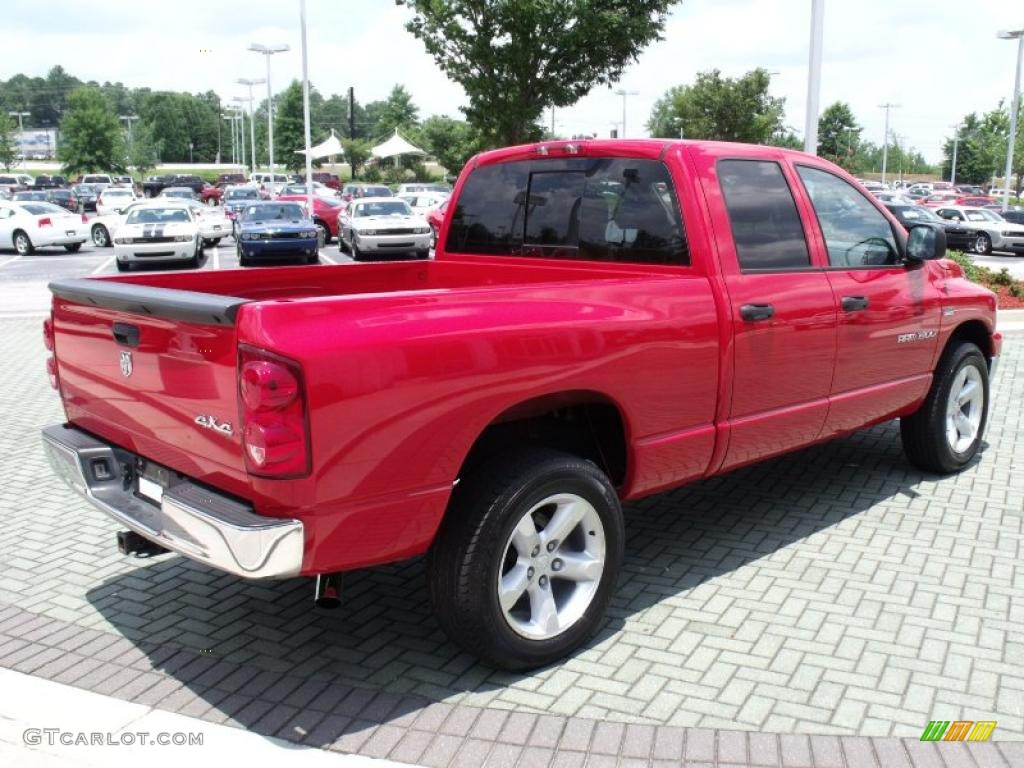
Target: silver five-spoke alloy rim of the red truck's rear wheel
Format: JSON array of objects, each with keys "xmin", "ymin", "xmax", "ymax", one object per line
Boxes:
[{"xmin": 496, "ymin": 494, "xmax": 606, "ymax": 640}]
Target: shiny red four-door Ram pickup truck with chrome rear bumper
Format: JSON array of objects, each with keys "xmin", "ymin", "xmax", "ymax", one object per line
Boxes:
[{"xmin": 43, "ymin": 140, "xmax": 1000, "ymax": 669}]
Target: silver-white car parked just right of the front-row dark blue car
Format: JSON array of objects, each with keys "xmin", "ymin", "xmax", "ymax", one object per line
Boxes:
[{"xmin": 338, "ymin": 198, "xmax": 430, "ymax": 261}]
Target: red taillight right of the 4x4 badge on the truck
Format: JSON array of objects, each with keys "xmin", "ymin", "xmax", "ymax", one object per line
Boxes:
[{"xmin": 239, "ymin": 345, "xmax": 311, "ymax": 477}]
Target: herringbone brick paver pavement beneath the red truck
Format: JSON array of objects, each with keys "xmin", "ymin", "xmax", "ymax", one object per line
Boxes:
[{"xmin": 0, "ymin": 319, "xmax": 1024, "ymax": 766}]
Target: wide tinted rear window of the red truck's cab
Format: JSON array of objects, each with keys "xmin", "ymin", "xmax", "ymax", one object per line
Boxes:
[{"xmin": 446, "ymin": 158, "xmax": 689, "ymax": 264}]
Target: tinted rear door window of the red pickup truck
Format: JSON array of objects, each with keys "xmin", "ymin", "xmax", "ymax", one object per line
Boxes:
[{"xmin": 718, "ymin": 160, "xmax": 811, "ymax": 269}]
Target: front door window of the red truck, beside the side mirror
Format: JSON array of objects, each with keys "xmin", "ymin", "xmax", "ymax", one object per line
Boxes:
[{"xmin": 797, "ymin": 166, "xmax": 899, "ymax": 266}]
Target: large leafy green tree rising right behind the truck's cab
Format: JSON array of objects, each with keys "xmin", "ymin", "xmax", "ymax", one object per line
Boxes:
[{"xmin": 395, "ymin": 0, "xmax": 675, "ymax": 144}]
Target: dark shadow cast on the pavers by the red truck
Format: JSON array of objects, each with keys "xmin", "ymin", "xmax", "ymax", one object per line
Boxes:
[{"xmin": 88, "ymin": 422, "xmax": 962, "ymax": 751}]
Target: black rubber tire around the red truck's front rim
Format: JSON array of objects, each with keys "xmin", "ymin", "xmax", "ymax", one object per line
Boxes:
[{"xmin": 900, "ymin": 341, "xmax": 988, "ymax": 474}]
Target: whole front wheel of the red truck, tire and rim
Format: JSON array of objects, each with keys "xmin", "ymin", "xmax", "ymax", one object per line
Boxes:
[{"xmin": 900, "ymin": 341, "xmax": 988, "ymax": 474}]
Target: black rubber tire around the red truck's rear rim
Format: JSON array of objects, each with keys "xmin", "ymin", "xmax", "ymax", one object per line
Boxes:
[{"xmin": 427, "ymin": 447, "xmax": 625, "ymax": 670}]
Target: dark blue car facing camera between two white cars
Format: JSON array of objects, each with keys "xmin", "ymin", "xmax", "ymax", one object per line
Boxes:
[{"xmin": 236, "ymin": 201, "xmax": 319, "ymax": 266}]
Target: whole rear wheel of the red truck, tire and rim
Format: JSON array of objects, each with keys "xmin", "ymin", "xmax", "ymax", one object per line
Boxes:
[{"xmin": 427, "ymin": 449, "xmax": 624, "ymax": 670}]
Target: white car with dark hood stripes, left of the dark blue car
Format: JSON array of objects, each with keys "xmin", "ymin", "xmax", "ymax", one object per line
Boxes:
[{"xmin": 114, "ymin": 202, "xmax": 203, "ymax": 271}]
